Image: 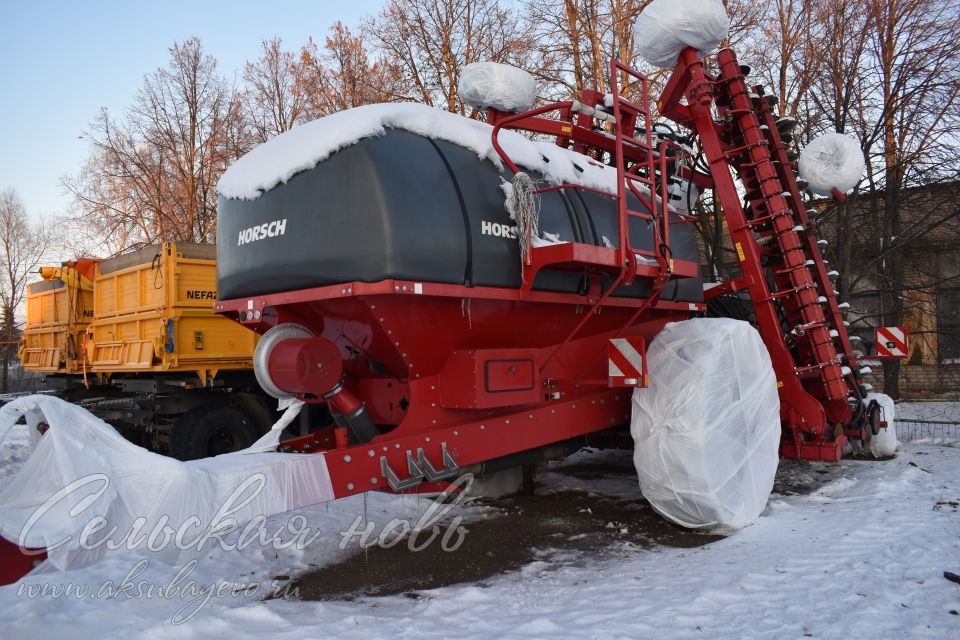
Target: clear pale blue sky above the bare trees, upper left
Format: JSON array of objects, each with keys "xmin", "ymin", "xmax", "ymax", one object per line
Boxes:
[{"xmin": 0, "ymin": 0, "xmax": 382, "ymax": 217}]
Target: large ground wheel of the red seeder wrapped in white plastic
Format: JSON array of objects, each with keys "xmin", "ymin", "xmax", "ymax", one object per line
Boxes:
[{"xmin": 630, "ymin": 318, "xmax": 780, "ymax": 530}]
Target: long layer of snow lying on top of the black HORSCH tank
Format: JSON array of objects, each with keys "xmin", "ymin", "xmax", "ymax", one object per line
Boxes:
[{"xmin": 217, "ymin": 103, "xmax": 632, "ymax": 200}]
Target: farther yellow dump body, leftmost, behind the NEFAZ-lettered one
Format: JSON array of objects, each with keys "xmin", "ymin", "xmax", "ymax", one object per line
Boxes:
[{"xmin": 19, "ymin": 258, "xmax": 98, "ymax": 374}]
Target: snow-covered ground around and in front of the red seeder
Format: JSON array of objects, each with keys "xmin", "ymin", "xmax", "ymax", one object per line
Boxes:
[{"xmin": 0, "ymin": 403, "xmax": 960, "ymax": 640}]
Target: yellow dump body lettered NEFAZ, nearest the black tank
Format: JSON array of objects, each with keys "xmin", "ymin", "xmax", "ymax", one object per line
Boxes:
[{"xmin": 87, "ymin": 242, "xmax": 257, "ymax": 386}]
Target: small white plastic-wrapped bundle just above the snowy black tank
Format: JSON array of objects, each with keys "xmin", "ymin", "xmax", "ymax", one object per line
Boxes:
[{"xmin": 457, "ymin": 62, "xmax": 537, "ymax": 112}]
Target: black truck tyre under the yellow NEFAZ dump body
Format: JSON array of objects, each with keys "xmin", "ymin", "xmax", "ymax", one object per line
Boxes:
[{"xmin": 170, "ymin": 405, "xmax": 257, "ymax": 460}]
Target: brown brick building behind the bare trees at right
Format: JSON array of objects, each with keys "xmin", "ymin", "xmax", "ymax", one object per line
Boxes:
[{"xmin": 698, "ymin": 182, "xmax": 960, "ymax": 398}]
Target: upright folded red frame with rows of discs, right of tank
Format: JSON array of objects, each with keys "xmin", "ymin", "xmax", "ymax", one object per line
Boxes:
[{"xmin": 659, "ymin": 49, "xmax": 862, "ymax": 461}]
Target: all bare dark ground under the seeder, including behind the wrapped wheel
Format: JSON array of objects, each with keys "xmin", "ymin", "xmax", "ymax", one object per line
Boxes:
[{"xmin": 292, "ymin": 452, "xmax": 864, "ymax": 600}]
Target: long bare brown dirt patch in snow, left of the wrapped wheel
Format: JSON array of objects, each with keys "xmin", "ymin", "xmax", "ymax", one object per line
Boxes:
[{"xmin": 292, "ymin": 488, "xmax": 720, "ymax": 600}]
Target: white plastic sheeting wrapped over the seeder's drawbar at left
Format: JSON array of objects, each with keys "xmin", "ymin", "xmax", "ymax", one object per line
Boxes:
[{"xmin": 0, "ymin": 395, "xmax": 334, "ymax": 569}]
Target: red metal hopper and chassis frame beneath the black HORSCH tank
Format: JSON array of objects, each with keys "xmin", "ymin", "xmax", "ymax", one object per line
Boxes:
[{"xmin": 217, "ymin": 281, "xmax": 688, "ymax": 497}]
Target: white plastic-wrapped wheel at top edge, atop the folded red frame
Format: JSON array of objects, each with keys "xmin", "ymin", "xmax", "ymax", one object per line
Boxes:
[{"xmin": 633, "ymin": 0, "xmax": 730, "ymax": 67}]
